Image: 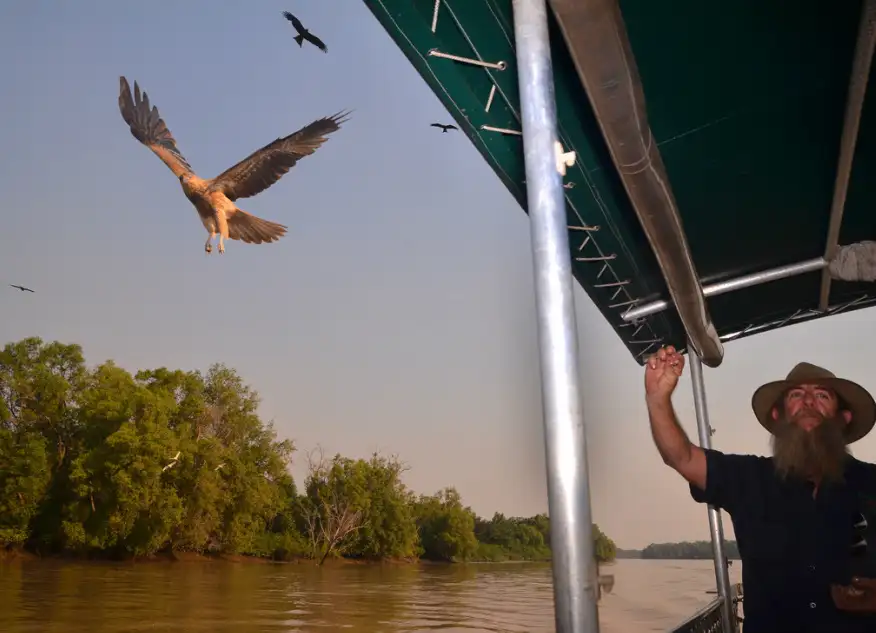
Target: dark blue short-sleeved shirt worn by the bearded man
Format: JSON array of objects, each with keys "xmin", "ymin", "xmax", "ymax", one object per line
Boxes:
[{"xmin": 690, "ymin": 450, "xmax": 876, "ymax": 633}]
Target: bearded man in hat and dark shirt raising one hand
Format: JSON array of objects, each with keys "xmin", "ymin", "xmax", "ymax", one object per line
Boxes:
[{"xmin": 645, "ymin": 347, "xmax": 876, "ymax": 633}]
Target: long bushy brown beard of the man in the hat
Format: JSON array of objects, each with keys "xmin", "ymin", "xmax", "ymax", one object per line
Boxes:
[{"xmin": 772, "ymin": 410, "xmax": 848, "ymax": 481}]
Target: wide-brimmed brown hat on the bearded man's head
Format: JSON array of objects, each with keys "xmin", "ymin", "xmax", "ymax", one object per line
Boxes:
[{"xmin": 751, "ymin": 363, "xmax": 876, "ymax": 444}]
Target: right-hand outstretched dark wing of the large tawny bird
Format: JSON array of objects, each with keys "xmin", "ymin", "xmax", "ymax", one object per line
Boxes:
[{"xmin": 210, "ymin": 112, "xmax": 349, "ymax": 201}]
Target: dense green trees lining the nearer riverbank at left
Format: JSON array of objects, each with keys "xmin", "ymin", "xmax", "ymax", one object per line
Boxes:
[{"xmin": 0, "ymin": 337, "xmax": 616, "ymax": 565}]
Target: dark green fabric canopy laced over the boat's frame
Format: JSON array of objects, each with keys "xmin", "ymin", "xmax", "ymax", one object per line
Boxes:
[{"xmin": 365, "ymin": 0, "xmax": 876, "ymax": 362}]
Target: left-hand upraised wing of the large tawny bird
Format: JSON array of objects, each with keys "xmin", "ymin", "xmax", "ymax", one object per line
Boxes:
[{"xmin": 119, "ymin": 77, "xmax": 194, "ymax": 178}]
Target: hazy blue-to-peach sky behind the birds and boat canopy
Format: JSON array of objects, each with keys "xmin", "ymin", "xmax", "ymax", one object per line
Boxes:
[{"xmin": 0, "ymin": 0, "xmax": 876, "ymax": 548}]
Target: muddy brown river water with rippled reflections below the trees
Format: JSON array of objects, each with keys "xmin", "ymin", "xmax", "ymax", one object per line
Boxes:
[{"xmin": 0, "ymin": 561, "xmax": 738, "ymax": 633}]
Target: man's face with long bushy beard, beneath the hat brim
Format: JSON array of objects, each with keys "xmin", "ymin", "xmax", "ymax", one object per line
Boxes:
[{"xmin": 772, "ymin": 385, "xmax": 851, "ymax": 480}]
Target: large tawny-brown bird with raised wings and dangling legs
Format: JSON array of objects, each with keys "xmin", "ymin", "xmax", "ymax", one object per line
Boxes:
[{"xmin": 119, "ymin": 77, "xmax": 349, "ymax": 253}]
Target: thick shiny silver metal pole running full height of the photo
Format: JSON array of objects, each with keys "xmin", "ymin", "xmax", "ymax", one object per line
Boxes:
[{"xmin": 513, "ymin": 0, "xmax": 599, "ymax": 633}]
